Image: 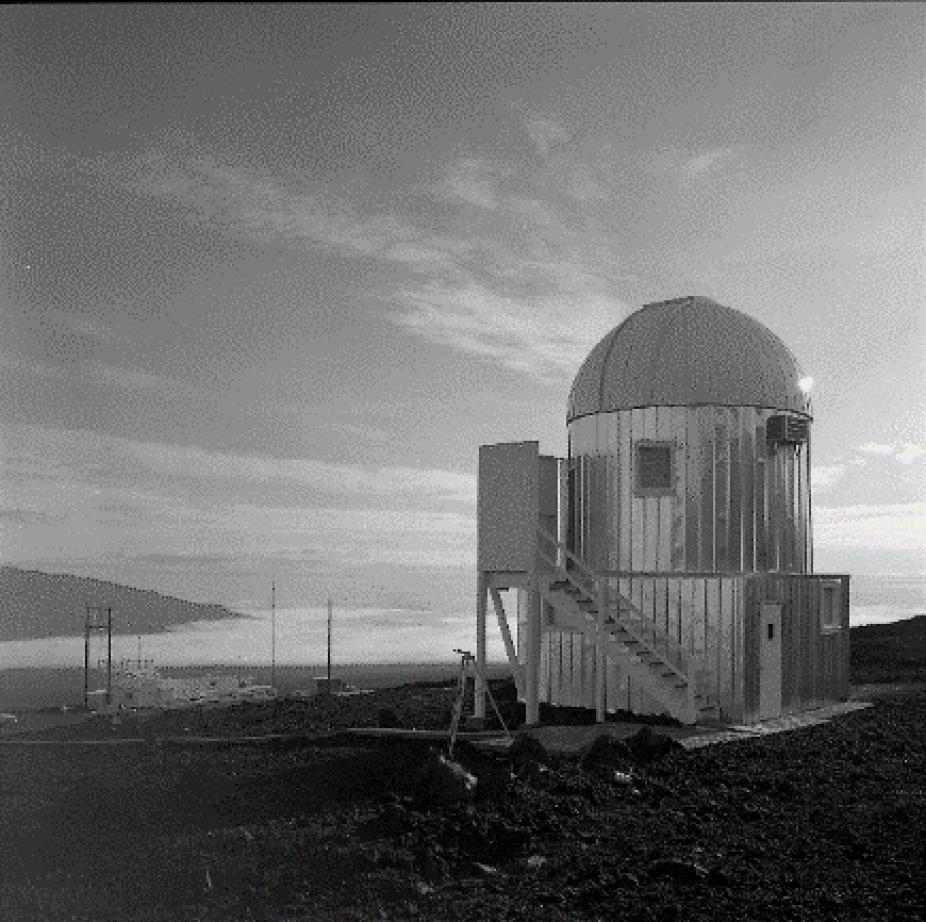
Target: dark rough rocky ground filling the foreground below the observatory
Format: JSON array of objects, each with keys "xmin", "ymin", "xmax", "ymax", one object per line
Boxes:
[{"xmin": 0, "ymin": 616, "xmax": 926, "ymax": 922}]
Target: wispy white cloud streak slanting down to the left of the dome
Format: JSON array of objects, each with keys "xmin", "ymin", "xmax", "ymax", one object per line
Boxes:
[{"xmin": 103, "ymin": 146, "xmax": 626, "ymax": 384}]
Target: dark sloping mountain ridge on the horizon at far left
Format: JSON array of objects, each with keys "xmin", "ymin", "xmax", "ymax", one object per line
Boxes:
[{"xmin": 0, "ymin": 566, "xmax": 242, "ymax": 641}]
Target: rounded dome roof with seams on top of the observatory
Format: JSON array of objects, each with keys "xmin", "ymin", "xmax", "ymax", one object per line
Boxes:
[{"xmin": 566, "ymin": 296, "xmax": 809, "ymax": 422}]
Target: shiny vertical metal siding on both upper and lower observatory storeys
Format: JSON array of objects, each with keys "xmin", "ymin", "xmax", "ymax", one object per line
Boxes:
[{"xmin": 545, "ymin": 407, "xmax": 820, "ymax": 720}]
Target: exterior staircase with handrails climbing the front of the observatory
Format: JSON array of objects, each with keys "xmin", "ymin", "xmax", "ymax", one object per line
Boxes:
[{"xmin": 538, "ymin": 528, "xmax": 720, "ymax": 724}]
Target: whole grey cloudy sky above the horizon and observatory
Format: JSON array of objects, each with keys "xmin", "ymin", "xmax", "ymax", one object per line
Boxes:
[{"xmin": 0, "ymin": 4, "xmax": 926, "ymax": 628}]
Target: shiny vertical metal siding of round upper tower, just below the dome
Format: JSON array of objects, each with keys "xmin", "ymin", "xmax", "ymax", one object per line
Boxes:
[{"xmin": 570, "ymin": 407, "xmax": 811, "ymax": 573}]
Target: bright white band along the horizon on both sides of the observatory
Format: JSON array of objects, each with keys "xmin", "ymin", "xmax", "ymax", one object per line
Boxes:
[{"xmin": 0, "ymin": 575, "xmax": 926, "ymax": 669}]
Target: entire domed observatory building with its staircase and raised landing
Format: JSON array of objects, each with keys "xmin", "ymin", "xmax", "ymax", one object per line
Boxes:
[{"xmin": 476, "ymin": 297, "xmax": 849, "ymax": 723}]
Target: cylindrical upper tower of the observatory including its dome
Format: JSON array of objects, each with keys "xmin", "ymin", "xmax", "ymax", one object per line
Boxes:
[{"xmin": 567, "ymin": 297, "xmax": 812, "ymax": 573}]
